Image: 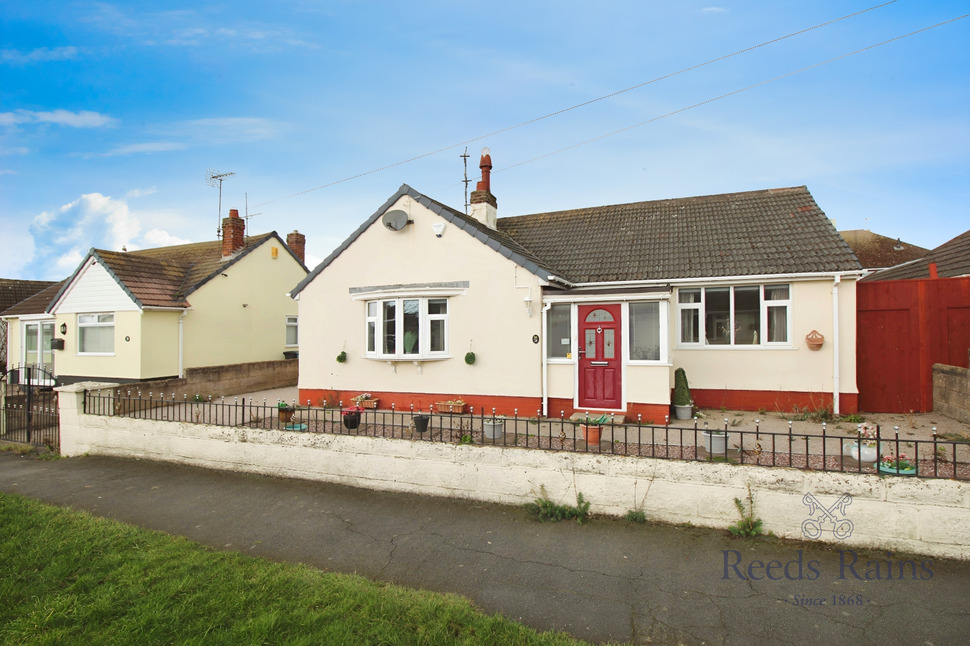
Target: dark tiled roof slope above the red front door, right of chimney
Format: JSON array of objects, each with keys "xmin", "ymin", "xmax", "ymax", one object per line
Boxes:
[{"xmin": 498, "ymin": 186, "xmax": 861, "ymax": 283}]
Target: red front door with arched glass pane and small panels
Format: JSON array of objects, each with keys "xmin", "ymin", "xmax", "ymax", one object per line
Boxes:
[{"xmin": 578, "ymin": 304, "xmax": 623, "ymax": 409}]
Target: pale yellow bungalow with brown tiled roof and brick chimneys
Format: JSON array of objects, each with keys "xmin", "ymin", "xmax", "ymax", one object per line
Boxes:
[{"xmin": 3, "ymin": 209, "xmax": 307, "ymax": 384}]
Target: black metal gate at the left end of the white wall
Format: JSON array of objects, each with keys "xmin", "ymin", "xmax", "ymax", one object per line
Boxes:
[{"xmin": 0, "ymin": 365, "xmax": 61, "ymax": 451}]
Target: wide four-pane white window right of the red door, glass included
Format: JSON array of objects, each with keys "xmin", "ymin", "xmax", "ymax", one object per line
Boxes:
[{"xmin": 677, "ymin": 284, "xmax": 791, "ymax": 347}]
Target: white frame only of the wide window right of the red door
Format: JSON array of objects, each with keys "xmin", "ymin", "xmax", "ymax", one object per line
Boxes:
[{"xmin": 675, "ymin": 283, "xmax": 793, "ymax": 349}]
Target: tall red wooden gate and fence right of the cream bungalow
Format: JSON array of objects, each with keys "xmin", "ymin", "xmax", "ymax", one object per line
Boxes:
[{"xmin": 856, "ymin": 278, "xmax": 970, "ymax": 413}]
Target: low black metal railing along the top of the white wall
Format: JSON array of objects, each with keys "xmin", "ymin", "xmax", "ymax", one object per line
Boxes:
[{"xmin": 84, "ymin": 390, "xmax": 970, "ymax": 480}]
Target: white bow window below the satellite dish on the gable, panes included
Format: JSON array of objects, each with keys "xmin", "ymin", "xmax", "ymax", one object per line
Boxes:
[{"xmin": 365, "ymin": 297, "xmax": 448, "ymax": 360}]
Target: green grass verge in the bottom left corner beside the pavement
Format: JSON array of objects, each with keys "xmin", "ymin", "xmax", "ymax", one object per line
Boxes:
[{"xmin": 0, "ymin": 494, "xmax": 581, "ymax": 646}]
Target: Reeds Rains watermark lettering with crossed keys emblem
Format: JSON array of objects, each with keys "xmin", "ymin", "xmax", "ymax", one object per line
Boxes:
[{"xmin": 721, "ymin": 493, "xmax": 933, "ymax": 588}]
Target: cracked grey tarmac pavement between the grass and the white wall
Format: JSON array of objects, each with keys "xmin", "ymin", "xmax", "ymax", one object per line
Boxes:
[{"xmin": 0, "ymin": 452, "xmax": 970, "ymax": 646}]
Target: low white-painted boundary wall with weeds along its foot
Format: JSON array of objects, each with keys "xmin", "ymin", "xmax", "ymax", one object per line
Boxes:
[{"xmin": 58, "ymin": 384, "xmax": 970, "ymax": 559}]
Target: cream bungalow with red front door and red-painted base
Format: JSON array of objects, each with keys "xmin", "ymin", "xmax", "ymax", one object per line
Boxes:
[{"xmin": 292, "ymin": 149, "xmax": 862, "ymax": 423}]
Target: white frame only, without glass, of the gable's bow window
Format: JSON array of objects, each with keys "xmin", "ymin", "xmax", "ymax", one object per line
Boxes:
[{"xmin": 364, "ymin": 294, "xmax": 451, "ymax": 361}]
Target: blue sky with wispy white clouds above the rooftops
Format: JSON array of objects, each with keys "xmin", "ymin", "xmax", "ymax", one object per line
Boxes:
[{"xmin": 0, "ymin": 0, "xmax": 970, "ymax": 280}]
